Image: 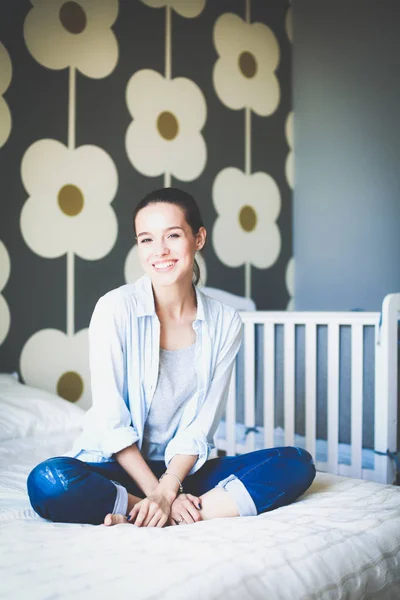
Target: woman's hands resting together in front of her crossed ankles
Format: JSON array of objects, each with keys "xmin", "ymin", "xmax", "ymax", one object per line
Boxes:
[{"xmin": 127, "ymin": 490, "xmax": 202, "ymax": 527}]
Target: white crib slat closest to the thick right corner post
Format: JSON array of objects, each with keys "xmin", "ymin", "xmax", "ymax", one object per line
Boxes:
[{"xmin": 351, "ymin": 323, "xmax": 364, "ymax": 478}]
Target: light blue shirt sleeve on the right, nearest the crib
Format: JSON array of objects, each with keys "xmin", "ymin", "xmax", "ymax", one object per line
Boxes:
[{"xmin": 165, "ymin": 312, "xmax": 243, "ymax": 475}]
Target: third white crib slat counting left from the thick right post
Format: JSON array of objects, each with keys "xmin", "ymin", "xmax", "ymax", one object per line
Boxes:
[{"xmin": 305, "ymin": 323, "xmax": 317, "ymax": 460}]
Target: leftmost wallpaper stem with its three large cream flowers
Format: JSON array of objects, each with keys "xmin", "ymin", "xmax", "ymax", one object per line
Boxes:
[{"xmin": 20, "ymin": 0, "xmax": 118, "ymax": 408}]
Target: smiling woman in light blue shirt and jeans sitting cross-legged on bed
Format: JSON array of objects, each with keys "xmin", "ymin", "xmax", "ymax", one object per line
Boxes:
[{"xmin": 28, "ymin": 188, "xmax": 315, "ymax": 527}]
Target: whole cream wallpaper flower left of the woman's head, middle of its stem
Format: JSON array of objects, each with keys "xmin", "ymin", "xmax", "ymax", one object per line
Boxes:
[{"xmin": 21, "ymin": 140, "xmax": 118, "ymax": 260}]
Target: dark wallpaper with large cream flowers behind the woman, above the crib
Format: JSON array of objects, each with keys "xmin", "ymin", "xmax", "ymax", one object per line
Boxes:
[{"xmin": 0, "ymin": 0, "xmax": 294, "ymax": 408}]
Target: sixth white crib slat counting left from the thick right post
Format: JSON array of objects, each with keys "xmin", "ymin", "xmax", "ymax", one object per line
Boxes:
[{"xmin": 244, "ymin": 322, "xmax": 256, "ymax": 452}]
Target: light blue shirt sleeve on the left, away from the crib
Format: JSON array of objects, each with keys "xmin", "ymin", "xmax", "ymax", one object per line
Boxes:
[{"xmin": 89, "ymin": 295, "xmax": 139, "ymax": 458}]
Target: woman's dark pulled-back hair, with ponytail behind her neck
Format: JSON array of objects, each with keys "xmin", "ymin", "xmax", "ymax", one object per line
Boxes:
[{"xmin": 133, "ymin": 188, "xmax": 204, "ymax": 285}]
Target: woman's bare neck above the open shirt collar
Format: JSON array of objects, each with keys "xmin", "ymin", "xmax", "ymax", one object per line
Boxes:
[{"xmin": 153, "ymin": 281, "xmax": 197, "ymax": 320}]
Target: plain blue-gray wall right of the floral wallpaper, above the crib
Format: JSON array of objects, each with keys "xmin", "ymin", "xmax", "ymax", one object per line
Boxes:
[{"xmin": 293, "ymin": 0, "xmax": 400, "ymax": 310}]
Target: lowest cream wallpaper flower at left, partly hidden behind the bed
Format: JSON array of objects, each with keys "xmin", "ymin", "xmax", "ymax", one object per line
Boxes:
[{"xmin": 20, "ymin": 329, "xmax": 91, "ymax": 409}]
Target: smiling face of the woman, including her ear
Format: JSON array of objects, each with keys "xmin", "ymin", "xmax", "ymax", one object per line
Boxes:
[{"xmin": 135, "ymin": 202, "xmax": 206, "ymax": 285}]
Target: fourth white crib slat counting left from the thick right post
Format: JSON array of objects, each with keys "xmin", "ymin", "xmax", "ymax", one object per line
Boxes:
[{"xmin": 283, "ymin": 323, "xmax": 295, "ymax": 446}]
